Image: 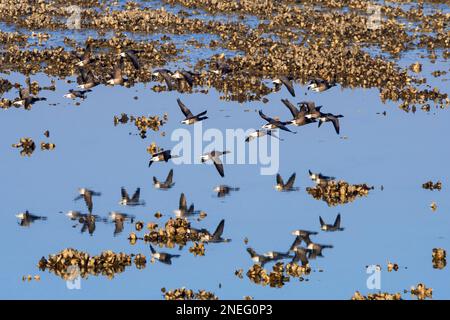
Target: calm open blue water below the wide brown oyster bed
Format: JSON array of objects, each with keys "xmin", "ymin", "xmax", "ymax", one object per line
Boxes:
[{"xmin": 0, "ymin": 1, "xmax": 450, "ymax": 299}]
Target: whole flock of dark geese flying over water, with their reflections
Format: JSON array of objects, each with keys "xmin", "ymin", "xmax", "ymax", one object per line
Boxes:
[{"xmin": 14, "ymin": 44, "xmax": 343, "ymax": 272}]
